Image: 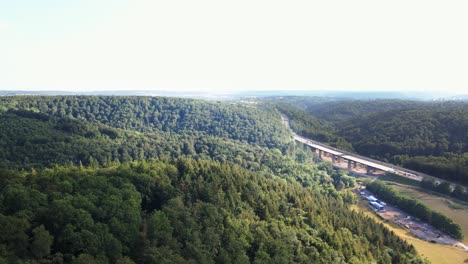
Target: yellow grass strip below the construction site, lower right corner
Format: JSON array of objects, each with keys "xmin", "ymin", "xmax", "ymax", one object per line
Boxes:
[{"xmin": 353, "ymin": 199, "xmax": 468, "ymax": 264}]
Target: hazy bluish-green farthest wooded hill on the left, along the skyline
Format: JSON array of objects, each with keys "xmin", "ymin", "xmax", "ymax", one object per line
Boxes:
[{"xmin": 0, "ymin": 96, "xmax": 286, "ymax": 147}]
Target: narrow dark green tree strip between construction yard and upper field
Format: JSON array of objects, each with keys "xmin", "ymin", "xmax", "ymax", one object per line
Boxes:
[{"xmin": 366, "ymin": 181, "xmax": 463, "ymax": 239}]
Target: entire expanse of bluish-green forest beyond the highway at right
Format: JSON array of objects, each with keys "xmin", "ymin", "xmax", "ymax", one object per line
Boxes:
[{"xmin": 276, "ymin": 99, "xmax": 468, "ymax": 184}]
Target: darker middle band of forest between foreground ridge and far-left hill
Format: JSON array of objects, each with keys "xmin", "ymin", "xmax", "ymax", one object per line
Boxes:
[{"xmin": 0, "ymin": 111, "xmax": 291, "ymax": 168}]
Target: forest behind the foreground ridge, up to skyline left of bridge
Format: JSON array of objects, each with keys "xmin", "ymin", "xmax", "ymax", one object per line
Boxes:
[{"xmin": 0, "ymin": 96, "xmax": 291, "ymax": 168}]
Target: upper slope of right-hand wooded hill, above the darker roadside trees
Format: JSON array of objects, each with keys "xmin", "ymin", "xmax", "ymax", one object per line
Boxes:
[{"xmin": 340, "ymin": 110, "xmax": 468, "ymax": 157}]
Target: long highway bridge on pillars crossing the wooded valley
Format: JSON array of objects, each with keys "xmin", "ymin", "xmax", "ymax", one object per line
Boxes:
[{"xmin": 281, "ymin": 115, "xmax": 429, "ymax": 181}]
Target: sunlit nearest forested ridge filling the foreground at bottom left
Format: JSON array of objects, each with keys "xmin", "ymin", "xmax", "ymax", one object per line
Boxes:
[{"xmin": 0, "ymin": 159, "xmax": 419, "ymax": 263}]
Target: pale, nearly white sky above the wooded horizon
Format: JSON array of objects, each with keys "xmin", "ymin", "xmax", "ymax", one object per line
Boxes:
[{"xmin": 0, "ymin": 0, "xmax": 468, "ymax": 94}]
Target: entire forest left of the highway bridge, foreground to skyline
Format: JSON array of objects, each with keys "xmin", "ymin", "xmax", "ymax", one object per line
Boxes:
[{"xmin": 0, "ymin": 96, "xmax": 423, "ymax": 263}]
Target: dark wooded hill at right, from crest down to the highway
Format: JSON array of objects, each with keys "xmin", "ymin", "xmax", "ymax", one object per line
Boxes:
[{"xmin": 339, "ymin": 110, "xmax": 468, "ymax": 184}]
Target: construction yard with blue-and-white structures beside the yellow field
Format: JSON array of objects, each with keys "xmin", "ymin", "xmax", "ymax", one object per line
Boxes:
[{"xmin": 357, "ymin": 187, "xmax": 468, "ymax": 251}]
